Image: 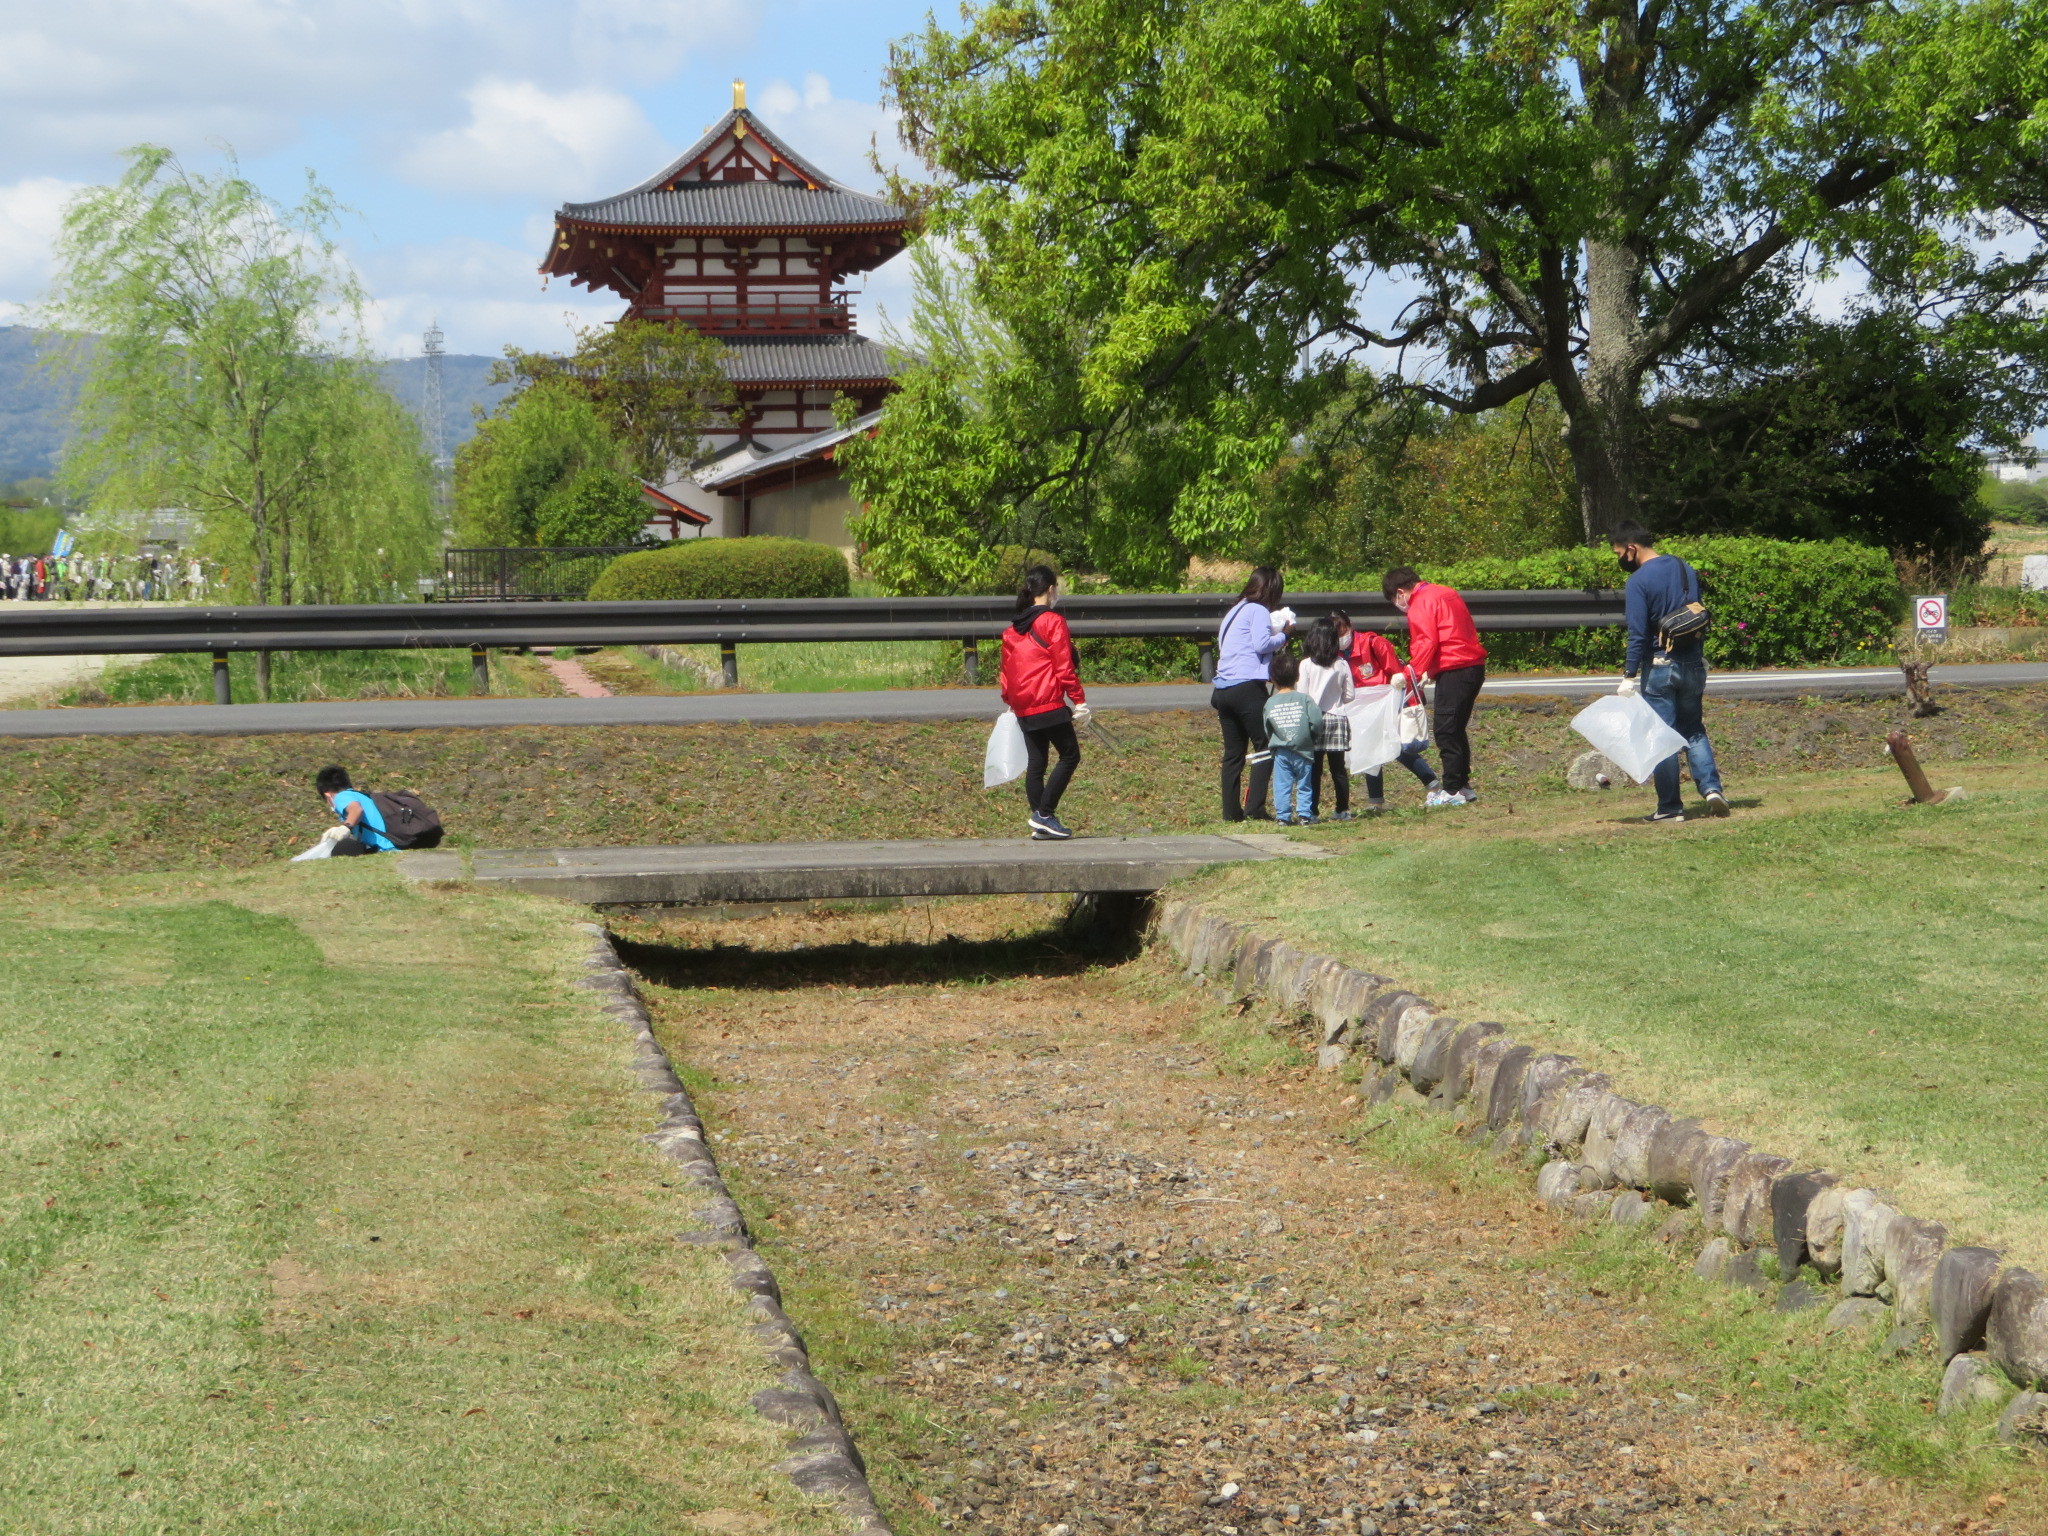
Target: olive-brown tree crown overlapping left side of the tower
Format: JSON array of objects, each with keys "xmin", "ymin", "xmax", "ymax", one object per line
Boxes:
[{"xmin": 489, "ymin": 319, "xmax": 733, "ymax": 485}]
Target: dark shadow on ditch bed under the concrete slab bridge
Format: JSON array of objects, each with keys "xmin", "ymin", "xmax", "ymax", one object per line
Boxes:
[{"xmin": 612, "ymin": 897, "xmax": 1149, "ymax": 991}]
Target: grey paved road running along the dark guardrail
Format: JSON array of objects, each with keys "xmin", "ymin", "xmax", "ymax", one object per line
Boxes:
[{"xmin": 0, "ymin": 662, "xmax": 2048, "ymax": 737}]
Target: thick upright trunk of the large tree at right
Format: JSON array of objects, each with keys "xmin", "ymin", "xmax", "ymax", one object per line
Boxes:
[{"xmin": 1567, "ymin": 240, "xmax": 1642, "ymax": 543}]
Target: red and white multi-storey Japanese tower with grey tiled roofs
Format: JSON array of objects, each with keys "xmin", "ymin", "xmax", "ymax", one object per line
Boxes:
[{"xmin": 541, "ymin": 82, "xmax": 905, "ymax": 547}]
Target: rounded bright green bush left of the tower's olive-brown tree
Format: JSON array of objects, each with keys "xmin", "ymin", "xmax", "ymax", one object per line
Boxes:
[{"xmin": 455, "ymin": 379, "xmax": 622, "ymax": 547}]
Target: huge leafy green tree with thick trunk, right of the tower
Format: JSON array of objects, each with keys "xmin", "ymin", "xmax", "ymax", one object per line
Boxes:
[{"xmin": 874, "ymin": 0, "xmax": 2048, "ymax": 573}]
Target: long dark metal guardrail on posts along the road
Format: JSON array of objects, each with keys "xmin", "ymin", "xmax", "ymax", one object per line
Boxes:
[{"xmin": 0, "ymin": 592, "xmax": 1626, "ymax": 705}]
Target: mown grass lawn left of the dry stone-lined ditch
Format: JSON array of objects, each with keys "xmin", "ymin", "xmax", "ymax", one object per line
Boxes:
[{"xmin": 0, "ymin": 862, "xmax": 836, "ymax": 1536}]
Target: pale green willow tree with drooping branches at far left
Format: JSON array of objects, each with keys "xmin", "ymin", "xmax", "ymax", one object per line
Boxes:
[{"xmin": 49, "ymin": 147, "xmax": 440, "ymax": 602}]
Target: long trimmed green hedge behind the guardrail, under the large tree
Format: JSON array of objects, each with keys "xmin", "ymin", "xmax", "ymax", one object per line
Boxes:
[{"xmin": 1409, "ymin": 539, "xmax": 1905, "ymax": 668}]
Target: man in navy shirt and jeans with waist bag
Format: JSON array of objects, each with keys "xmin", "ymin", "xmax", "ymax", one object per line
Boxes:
[{"xmin": 1610, "ymin": 522, "xmax": 1729, "ymax": 821}]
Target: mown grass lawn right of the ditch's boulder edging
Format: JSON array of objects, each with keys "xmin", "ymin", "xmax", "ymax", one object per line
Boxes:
[{"xmin": 1206, "ymin": 766, "xmax": 2048, "ymax": 1264}]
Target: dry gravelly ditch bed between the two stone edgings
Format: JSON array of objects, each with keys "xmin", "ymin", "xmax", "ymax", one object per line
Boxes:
[{"xmin": 621, "ymin": 901, "xmax": 1998, "ymax": 1536}]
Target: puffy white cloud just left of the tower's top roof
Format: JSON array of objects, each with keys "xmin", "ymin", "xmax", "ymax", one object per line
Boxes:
[{"xmin": 399, "ymin": 80, "xmax": 664, "ymax": 199}]
